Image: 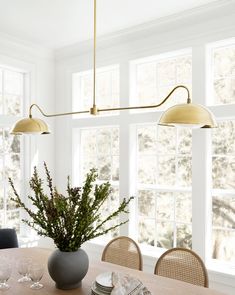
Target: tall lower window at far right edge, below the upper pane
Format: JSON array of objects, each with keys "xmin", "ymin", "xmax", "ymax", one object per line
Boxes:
[{"xmin": 212, "ymin": 121, "xmax": 235, "ymax": 262}]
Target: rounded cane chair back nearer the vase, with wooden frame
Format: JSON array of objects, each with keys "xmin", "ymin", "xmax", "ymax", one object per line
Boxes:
[{"xmin": 101, "ymin": 236, "xmax": 143, "ymax": 270}]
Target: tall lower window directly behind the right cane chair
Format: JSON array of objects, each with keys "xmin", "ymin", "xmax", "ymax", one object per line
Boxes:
[{"xmin": 137, "ymin": 124, "xmax": 192, "ymax": 249}]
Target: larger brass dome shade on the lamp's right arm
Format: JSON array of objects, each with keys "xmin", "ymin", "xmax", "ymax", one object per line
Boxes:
[{"xmin": 158, "ymin": 103, "xmax": 216, "ymax": 128}]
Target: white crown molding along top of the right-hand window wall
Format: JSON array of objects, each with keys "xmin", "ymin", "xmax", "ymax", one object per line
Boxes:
[{"xmin": 55, "ymin": 0, "xmax": 235, "ymax": 61}]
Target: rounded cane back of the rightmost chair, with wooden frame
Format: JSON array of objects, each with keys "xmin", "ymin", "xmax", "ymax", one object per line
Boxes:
[{"xmin": 154, "ymin": 248, "xmax": 209, "ymax": 287}]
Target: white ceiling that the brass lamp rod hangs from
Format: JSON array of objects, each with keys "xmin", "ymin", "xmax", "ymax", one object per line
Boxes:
[{"xmin": 0, "ymin": 0, "xmax": 221, "ymax": 48}]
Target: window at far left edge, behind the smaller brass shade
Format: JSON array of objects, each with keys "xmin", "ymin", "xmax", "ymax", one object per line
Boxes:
[{"xmin": 0, "ymin": 68, "xmax": 24, "ymax": 232}]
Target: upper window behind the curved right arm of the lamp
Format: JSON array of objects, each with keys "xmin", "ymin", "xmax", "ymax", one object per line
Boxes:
[{"xmin": 133, "ymin": 53, "xmax": 192, "ymax": 109}]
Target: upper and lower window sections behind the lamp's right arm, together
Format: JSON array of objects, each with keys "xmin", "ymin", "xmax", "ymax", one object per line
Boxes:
[{"xmin": 133, "ymin": 50, "xmax": 192, "ymax": 249}]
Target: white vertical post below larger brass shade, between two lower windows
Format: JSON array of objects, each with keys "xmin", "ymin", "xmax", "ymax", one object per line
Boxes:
[{"xmin": 192, "ymin": 129, "xmax": 212, "ymax": 260}]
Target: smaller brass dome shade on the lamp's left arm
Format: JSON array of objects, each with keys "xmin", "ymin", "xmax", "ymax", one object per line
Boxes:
[{"xmin": 10, "ymin": 118, "xmax": 50, "ymax": 135}]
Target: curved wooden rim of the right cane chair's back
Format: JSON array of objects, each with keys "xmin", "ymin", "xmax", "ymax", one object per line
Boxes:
[{"xmin": 154, "ymin": 247, "xmax": 209, "ymax": 288}]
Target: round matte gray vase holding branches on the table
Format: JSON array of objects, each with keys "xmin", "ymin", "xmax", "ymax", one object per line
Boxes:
[{"xmin": 47, "ymin": 249, "xmax": 89, "ymax": 290}]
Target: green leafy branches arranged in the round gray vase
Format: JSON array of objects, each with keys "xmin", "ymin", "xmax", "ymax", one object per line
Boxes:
[{"xmin": 9, "ymin": 163, "xmax": 133, "ymax": 252}]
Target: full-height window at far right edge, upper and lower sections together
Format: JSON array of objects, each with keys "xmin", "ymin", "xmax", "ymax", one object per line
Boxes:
[{"xmin": 211, "ymin": 40, "xmax": 235, "ymax": 263}]
